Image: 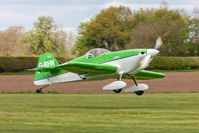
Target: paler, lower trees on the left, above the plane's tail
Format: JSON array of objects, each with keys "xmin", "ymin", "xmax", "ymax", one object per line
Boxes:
[{"xmin": 0, "ymin": 16, "xmax": 74, "ymax": 57}]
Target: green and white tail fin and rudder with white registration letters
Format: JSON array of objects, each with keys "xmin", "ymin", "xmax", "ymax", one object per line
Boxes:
[{"xmin": 34, "ymin": 53, "xmax": 59, "ymax": 85}]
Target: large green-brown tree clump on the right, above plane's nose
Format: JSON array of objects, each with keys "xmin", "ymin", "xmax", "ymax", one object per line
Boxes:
[{"xmin": 73, "ymin": 6, "xmax": 199, "ymax": 56}]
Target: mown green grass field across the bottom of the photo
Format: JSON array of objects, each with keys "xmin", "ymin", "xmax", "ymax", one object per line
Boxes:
[{"xmin": 0, "ymin": 93, "xmax": 199, "ymax": 133}]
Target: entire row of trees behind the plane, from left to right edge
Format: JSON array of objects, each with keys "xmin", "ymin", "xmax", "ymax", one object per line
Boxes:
[{"xmin": 0, "ymin": 6, "xmax": 199, "ymax": 57}]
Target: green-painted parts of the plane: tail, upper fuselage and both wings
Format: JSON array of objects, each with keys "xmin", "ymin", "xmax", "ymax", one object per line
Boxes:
[{"xmin": 33, "ymin": 49, "xmax": 165, "ymax": 80}]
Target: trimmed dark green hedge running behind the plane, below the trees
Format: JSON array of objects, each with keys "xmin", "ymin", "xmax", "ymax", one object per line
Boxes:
[{"xmin": 0, "ymin": 56, "xmax": 199, "ymax": 72}]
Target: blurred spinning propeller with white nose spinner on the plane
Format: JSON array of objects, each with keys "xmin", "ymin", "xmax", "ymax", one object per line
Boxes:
[{"xmin": 140, "ymin": 37, "xmax": 163, "ymax": 69}]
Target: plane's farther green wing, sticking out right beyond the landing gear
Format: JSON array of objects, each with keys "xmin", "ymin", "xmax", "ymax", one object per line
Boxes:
[{"xmin": 124, "ymin": 70, "xmax": 165, "ymax": 80}]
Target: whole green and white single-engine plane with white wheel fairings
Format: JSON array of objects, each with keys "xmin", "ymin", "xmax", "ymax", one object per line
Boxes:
[{"xmin": 29, "ymin": 37, "xmax": 165, "ymax": 95}]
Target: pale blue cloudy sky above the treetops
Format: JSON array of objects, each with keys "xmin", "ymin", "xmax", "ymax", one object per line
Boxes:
[{"xmin": 0, "ymin": 0, "xmax": 199, "ymax": 33}]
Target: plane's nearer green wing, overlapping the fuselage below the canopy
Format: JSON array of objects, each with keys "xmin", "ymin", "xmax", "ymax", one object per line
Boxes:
[{"xmin": 54, "ymin": 62, "xmax": 118, "ymax": 74}]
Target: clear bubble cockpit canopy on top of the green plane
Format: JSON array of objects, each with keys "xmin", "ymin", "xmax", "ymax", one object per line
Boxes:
[{"xmin": 86, "ymin": 48, "xmax": 110, "ymax": 58}]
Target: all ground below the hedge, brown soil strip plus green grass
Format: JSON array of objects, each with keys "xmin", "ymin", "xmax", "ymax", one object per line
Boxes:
[{"xmin": 0, "ymin": 72, "xmax": 199, "ymax": 133}]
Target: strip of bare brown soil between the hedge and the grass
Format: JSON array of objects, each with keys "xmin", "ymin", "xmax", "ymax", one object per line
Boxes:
[{"xmin": 0, "ymin": 72, "xmax": 199, "ymax": 93}]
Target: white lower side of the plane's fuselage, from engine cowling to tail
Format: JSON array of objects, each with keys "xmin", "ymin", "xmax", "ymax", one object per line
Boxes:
[{"xmin": 34, "ymin": 55, "xmax": 144, "ymax": 85}]
